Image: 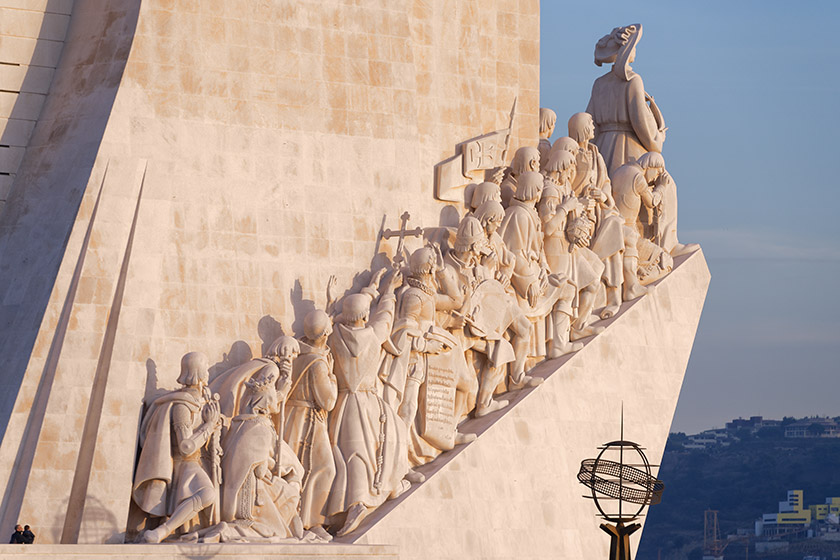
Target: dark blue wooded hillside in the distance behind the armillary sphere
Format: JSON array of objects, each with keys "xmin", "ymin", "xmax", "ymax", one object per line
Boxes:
[{"xmin": 637, "ymin": 429, "xmax": 840, "ymax": 560}]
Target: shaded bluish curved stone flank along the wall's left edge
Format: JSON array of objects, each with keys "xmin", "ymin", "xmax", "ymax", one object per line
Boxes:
[{"xmin": 0, "ymin": 1, "xmax": 140, "ymax": 540}]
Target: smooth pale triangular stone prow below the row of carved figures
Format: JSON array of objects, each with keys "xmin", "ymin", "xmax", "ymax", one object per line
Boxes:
[{"xmin": 348, "ymin": 250, "xmax": 710, "ymax": 560}]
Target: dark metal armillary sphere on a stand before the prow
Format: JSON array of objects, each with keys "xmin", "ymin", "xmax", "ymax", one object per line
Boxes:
[{"xmin": 577, "ymin": 414, "xmax": 665, "ymax": 560}]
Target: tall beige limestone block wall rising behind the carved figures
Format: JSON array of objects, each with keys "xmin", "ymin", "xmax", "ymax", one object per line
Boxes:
[{"xmin": 0, "ymin": 0, "xmax": 539, "ymax": 543}]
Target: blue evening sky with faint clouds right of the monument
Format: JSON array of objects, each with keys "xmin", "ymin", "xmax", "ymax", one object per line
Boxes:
[{"xmin": 540, "ymin": 0, "xmax": 840, "ymax": 433}]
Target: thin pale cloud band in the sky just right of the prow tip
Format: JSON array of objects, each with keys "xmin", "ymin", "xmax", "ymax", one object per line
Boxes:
[{"xmin": 680, "ymin": 229, "xmax": 840, "ymax": 261}]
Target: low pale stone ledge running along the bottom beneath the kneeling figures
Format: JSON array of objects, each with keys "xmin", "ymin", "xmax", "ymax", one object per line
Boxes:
[{"xmin": 0, "ymin": 543, "xmax": 399, "ymax": 560}]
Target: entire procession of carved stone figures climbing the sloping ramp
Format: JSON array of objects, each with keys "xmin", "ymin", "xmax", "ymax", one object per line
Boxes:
[{"xmin": 132, "ymin": 25, "xmax": 696, "ymax": 542}]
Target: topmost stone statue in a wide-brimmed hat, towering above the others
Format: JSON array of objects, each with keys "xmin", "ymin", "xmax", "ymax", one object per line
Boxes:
[{"xmin": 586, "ymin": 24, "xmax": 666, "ymax": 176}]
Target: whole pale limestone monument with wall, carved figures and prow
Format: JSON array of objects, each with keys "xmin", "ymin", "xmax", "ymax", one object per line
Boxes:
[{"xmin": 0, "ymin": 4, "xmax": 709, "ymax": 558}]
